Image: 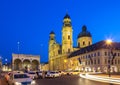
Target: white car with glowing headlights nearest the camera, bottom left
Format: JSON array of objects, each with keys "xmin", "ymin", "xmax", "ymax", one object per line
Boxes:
[{"xmin": 9, "ymin": 73, "xmax": 36, "ymax": 85}]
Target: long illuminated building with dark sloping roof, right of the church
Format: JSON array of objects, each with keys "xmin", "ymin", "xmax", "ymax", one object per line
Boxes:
[{"xmin": 67, "ymin": 41, "xmax": 120, "ymax": 72}]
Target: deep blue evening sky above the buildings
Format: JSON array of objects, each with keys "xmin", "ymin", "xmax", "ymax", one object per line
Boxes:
[{"xmin": 0, "ymin": 0, "xmax": 120, "ymax": 62}]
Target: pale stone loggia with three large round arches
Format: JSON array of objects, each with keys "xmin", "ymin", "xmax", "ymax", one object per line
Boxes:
[{"xmin": 12, "ymin": 54, "xmax": 40, "ymax": 70}]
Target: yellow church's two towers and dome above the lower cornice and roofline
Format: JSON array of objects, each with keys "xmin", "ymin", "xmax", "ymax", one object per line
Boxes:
[{"xmin": 49, "ymin": 14, "xmax": 92, "ymax": 70}]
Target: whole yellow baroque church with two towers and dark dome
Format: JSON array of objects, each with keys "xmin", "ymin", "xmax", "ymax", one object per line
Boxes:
[{"xmin": 49, "ymin": 14, "xmax": 92, "ymax": 70}]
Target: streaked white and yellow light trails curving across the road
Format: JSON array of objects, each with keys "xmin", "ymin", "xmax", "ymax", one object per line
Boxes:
[{"xmin": 80, "ymin": 73, "xmax": 120, "ymax": 85}]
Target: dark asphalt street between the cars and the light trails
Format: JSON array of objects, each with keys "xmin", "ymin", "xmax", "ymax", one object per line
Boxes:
[{"xmin": 36, "ymin": 76, "xmax": 116, "ymax": 85}]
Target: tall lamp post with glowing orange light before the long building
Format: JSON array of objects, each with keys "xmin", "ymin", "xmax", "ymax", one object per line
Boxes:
[{"xmin": 106, "ymin": 39, "xmax": 113, "ymax": 77}]
